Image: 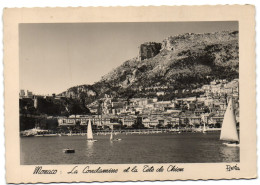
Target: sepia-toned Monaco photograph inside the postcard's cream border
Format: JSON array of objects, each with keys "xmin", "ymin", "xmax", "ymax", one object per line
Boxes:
[{"xmin": 19, "ymin": 21, "xmax": 240, "ymax": 165}]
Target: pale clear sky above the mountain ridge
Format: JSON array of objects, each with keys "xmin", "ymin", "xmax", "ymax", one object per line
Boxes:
[{"xmin": 19, "ymin": 21, "xmax": 238, "ymax": 95}]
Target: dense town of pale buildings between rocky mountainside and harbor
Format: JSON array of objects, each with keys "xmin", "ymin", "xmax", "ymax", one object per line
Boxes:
[{"xmin": 20, "ymin": 79, "xmax": 239, "ymax": 132}]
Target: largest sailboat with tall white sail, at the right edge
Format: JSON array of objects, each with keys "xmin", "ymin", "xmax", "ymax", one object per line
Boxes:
[{"xmin": 220, "ymin": 98, "xmax": 239, "ymax": 146}]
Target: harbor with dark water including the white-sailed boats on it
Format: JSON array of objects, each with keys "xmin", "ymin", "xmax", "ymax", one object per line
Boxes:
[{"xmin": 20, "ymin": 99, "xmax": 240, "ymax": 165}]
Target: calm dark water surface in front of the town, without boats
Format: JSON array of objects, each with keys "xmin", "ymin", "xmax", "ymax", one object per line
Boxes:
[{"xmin": 20, "ymin": 133, "xmax": 239, "ymax": 165}]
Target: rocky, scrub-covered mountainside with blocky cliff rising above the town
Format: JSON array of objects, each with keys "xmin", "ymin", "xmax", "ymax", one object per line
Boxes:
[{"xmin": 60, "ymin": 31, "xmax": 239, "ymax": 102}]
